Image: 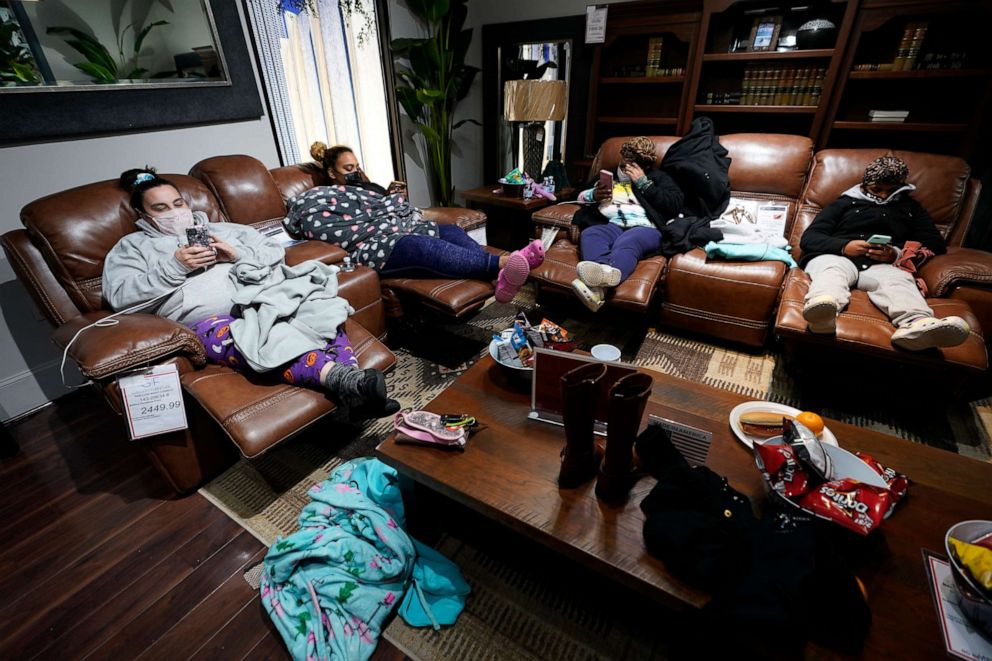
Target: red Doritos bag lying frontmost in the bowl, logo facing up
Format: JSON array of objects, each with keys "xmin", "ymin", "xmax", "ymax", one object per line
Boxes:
[{"xmin": 799, "ymin": 479, "xmax": 892, "ymax": 535}]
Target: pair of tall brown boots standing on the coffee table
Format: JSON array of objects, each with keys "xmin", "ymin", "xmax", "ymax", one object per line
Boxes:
[{"xmin": 558, "ymin": 363, "xmax": 654, "ymax": 504}]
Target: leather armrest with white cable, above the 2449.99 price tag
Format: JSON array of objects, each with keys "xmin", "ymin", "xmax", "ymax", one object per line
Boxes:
[{"xmin": 52, "ymin": 310, "xmax": 207, "ymax": 379}]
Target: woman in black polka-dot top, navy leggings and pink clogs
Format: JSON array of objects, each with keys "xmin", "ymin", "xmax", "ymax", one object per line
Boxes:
[{"xmin": 294, "ymin": 142, "xmax": 544, "ymax": 303}]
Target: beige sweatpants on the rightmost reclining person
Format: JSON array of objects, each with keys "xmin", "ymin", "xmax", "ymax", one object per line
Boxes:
[{"xmin": 805, "ymin": 255, "xmax": 933, "ymax": 326}]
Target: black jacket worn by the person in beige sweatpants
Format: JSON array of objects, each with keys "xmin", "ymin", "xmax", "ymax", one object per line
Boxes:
[{"xmin": 799, "ymin": 193, "xmax": 947, "ymax": 270}]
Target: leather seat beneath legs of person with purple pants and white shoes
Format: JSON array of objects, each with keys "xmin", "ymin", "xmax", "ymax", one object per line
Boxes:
[{"xmin": 530, "ymin": 239, "xmax": 665, "ymax": 312}]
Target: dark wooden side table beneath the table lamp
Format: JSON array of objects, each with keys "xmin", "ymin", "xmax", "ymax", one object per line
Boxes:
[{"xmin": 461, "ymin": 184, "xmax": 575, "ymax": 250}]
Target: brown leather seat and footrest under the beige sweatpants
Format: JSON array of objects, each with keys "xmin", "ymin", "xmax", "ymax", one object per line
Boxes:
[{"xmin": 775, "ymin": 269, "xmax": 988, "ymax": 372}]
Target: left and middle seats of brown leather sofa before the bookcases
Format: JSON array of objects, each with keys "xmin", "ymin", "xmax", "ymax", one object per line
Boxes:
[{"xmin": 531, "ymin": 133, "xmax": 813, "ymax": 347}]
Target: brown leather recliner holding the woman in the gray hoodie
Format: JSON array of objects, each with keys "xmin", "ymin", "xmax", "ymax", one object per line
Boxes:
[{"xmin": 0, "ymin": 174, "xmax": 395, "ymax": 493}]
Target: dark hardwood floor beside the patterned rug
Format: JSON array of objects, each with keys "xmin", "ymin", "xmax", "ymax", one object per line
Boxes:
[{"xmin": 0, "ymin": 391, "xmax": 406, "ymax": 661}]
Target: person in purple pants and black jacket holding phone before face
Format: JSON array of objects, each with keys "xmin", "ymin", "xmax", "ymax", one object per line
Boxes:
[{"xmin": 572, "ymin": 136, "xmax": 683, "ymax": 311}]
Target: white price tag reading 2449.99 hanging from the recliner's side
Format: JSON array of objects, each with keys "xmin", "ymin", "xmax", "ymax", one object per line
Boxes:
[{"xmin": 117, "ymin": 365, "xmax": 188, "ymax": 441}]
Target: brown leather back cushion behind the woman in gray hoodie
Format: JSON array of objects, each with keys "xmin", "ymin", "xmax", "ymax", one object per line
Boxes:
[{"xmin": 21, "ymin": 174, "xmax": 226, "ymax": 312}]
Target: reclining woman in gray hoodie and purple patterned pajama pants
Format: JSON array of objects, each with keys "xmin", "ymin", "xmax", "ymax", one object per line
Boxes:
[{"xmin": 103, "ymin": 168, "xmax": 399, "ymax": 417}]
